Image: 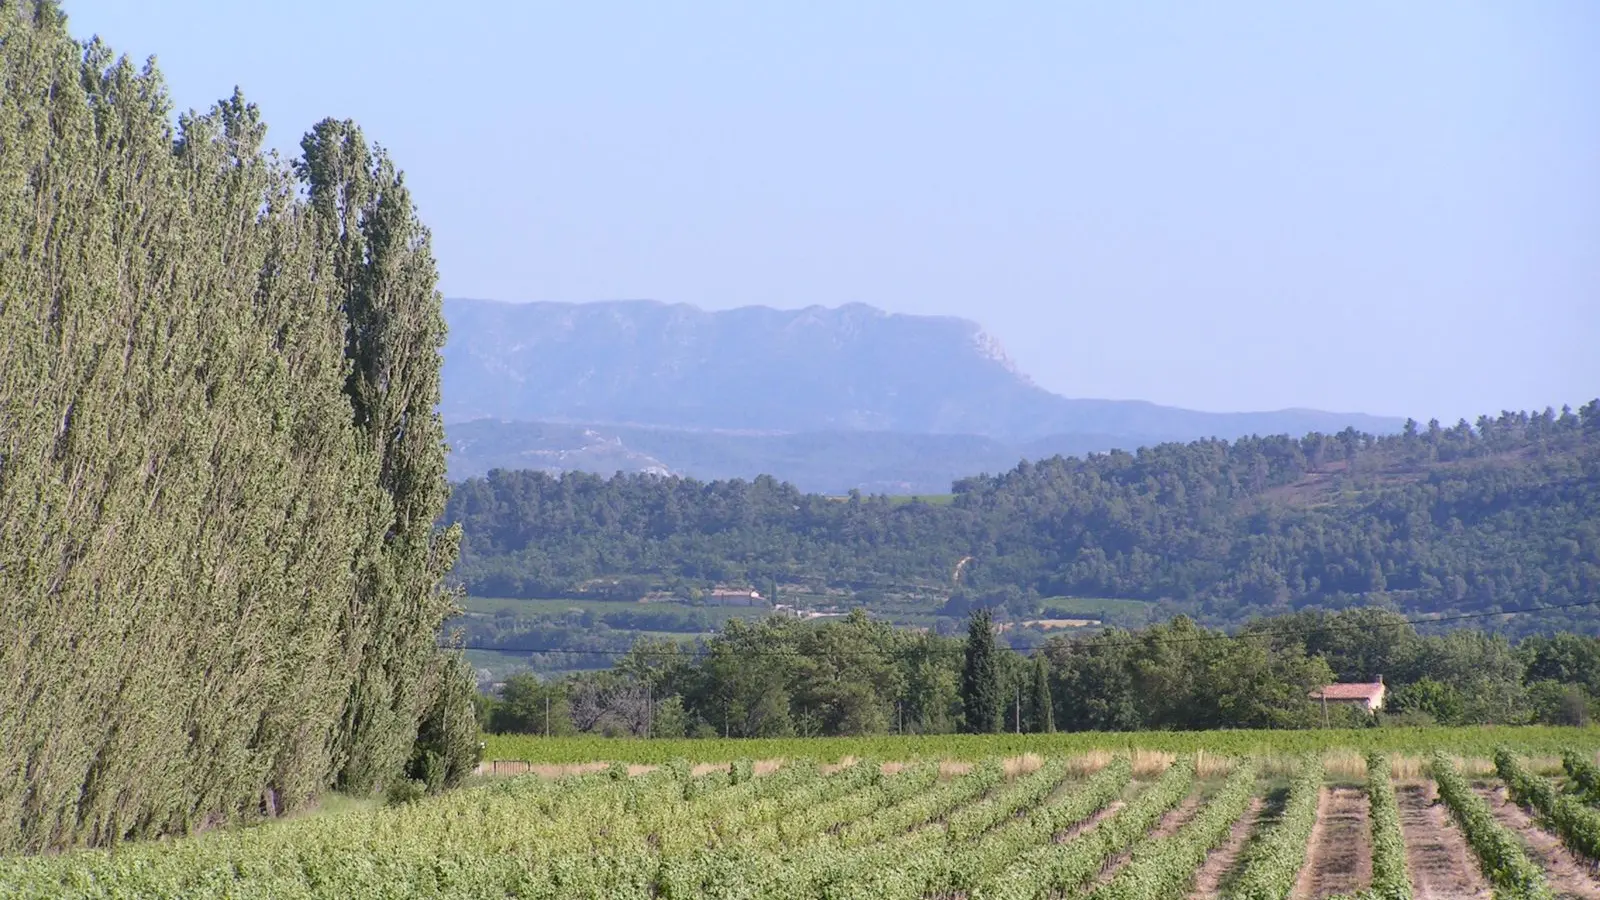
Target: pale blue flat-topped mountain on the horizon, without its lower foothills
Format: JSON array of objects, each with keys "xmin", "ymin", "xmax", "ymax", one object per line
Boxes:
[{"xmin": 442, "ymin": 299, "xmax": 1400, "ymax": 445}]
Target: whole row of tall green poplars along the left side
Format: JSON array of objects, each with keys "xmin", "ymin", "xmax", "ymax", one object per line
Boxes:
[{"xmin": 0, "ymin": 0, "xmax": 477, "ymax": 852}]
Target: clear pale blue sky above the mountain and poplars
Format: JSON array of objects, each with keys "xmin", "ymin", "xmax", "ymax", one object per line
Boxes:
[{"xmin": 66, "ymin": 0, "xmax": 1600, "ymax": 420}]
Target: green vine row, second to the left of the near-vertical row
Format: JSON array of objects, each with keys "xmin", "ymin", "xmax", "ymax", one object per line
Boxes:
[{"xmin": 1090, "ymin": 762, "xmax": 1256, "ymax": 900}]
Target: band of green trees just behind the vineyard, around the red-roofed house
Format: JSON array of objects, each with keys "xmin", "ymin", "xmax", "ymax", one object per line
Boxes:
[{"xmin": 478, "ymin": 610, "xmax": 1600, "ymax": 737}]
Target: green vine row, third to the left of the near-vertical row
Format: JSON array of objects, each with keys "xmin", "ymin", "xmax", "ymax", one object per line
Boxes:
[{"xmin": 973, "ymin": 757, "xmax": 1195, "ymax": 900}]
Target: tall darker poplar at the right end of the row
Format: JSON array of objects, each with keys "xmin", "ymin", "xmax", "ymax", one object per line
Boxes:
[{"xmin": 296, "ymin": 119, "xmax": 459, "ymax": 791}]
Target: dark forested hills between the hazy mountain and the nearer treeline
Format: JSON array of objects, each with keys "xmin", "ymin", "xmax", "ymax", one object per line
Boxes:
[{"xmin": 445, "ymin": 402, "xmax": 1600, "ymax": 631}]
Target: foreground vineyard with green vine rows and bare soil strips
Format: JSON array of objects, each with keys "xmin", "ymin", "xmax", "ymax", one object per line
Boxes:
[{"xmin": 9, "ymin": 743, "xmax": 1600, "ymax": 900}]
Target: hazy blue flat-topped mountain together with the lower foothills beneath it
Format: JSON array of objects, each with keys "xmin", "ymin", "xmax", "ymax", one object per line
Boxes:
[{"xmin": 442, "ymin": 299, "xmax": 1402, "ymax": 493}]
